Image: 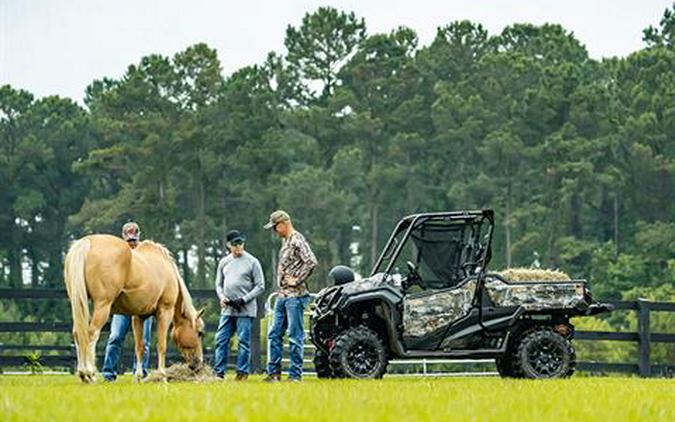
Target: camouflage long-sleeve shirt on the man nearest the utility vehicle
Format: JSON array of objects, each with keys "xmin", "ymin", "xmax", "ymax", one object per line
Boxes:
[{"xmin": 277, "ymin": 231, "xmax": 317, "ymax": 296}]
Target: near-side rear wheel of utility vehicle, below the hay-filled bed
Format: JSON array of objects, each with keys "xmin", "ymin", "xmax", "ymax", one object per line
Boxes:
[{"xmin": 512, "ymin": 327, "xmax": 576, "ymax": 378}]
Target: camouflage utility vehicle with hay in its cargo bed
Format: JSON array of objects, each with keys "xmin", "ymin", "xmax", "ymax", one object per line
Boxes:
[{"xmin": 310, "ymin": 210, "xmax": 609, "ymax": 378}]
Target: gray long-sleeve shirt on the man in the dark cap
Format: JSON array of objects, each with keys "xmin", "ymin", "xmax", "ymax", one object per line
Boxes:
[{"xmin": 216, "ymin": 251, "xmax": 265, "ymax": 317}]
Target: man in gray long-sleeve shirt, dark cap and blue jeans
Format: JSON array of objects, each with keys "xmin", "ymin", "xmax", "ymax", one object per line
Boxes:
[{"xmin": 213, "ymin": 230, "xmax": 265, "ymax": 381}]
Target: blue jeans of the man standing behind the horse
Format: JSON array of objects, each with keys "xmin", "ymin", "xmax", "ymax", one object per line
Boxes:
[{"xmin": 103, "ymin": 314, "xmax": 152, "ymax": 381}]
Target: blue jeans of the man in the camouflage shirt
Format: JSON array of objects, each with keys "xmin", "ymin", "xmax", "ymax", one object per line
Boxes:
[{"xmin": 267, "ymin": 295, "xmax": 309, "ymax": 379}]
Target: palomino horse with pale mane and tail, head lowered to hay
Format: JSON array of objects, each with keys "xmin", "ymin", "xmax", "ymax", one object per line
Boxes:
[{"xmin": 64, "ymin": 235, "xmax": 204, "ymax": 382}]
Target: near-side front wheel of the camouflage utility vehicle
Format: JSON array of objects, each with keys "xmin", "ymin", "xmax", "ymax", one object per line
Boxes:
[{"xmin": 329, "ymin": 327, "xmax": 388, "ymax": 379}]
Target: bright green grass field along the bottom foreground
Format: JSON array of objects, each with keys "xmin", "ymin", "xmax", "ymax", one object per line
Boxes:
[{"xmin": 0, "ymin": 375, "xmax": 675, "ymax": 422}]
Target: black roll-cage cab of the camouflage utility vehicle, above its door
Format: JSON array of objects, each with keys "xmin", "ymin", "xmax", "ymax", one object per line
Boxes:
[{"xmin": 374, "ymin": 215, "xmax": 492, "ymax": 288}]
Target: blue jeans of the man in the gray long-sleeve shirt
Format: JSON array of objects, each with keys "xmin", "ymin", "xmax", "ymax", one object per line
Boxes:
[{"xmin": 213, "ymin": 315, "xmax": 253, "ymax": 377}]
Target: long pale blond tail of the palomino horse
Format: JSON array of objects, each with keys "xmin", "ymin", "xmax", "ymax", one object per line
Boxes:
[{"xmin": 63, "ymin": 238, "xmax": 91, "ymax": 344}]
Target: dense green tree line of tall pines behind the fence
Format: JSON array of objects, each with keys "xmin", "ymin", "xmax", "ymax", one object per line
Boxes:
[{"xmin": 0, "ymin": 5, "xmax": 675, "ymax": 306}]
